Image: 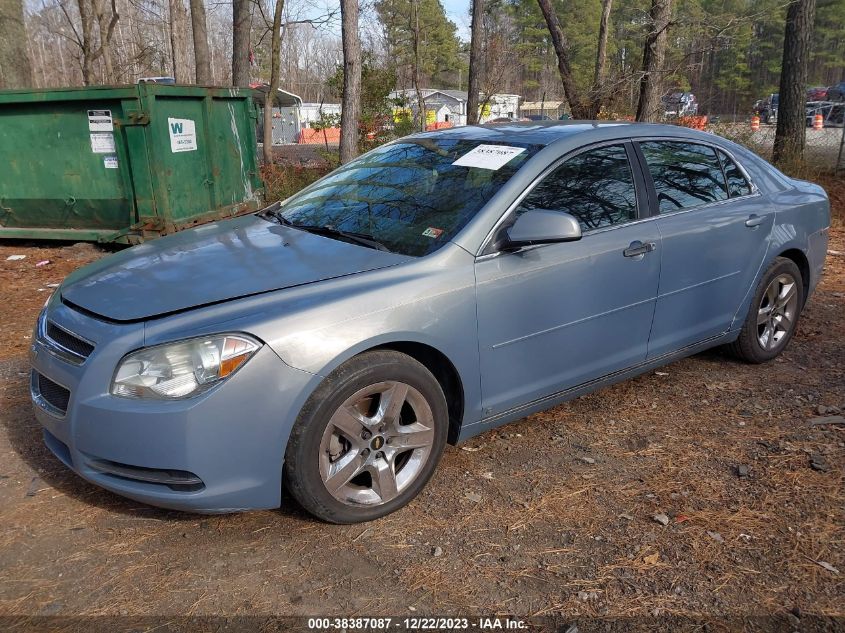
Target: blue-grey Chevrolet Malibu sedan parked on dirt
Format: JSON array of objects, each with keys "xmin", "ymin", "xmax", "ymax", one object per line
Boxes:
[{"xmin": 31, "ymin": 122, "xmax": 830, "ymax": 523}]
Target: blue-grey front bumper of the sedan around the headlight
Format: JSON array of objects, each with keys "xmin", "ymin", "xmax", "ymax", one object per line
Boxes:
[{"xmin": 32, "ymin": 300, "xmax": 316, "ymax": 513}]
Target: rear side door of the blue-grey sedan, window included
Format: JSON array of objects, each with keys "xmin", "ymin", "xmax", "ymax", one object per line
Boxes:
[{"xmin": 639, "ymin": 140, "xmax": 774, "ymax": 358}]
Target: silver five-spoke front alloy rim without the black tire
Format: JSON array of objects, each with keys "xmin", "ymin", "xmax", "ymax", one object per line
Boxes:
[{"xmin": 319, "ymin": 381, "xmax": 435, "ymax": 506}]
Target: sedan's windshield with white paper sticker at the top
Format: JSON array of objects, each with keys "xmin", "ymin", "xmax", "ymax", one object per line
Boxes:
[{"xmin": 276, "ymin": 138, "xmax": 541, "ymax": 256}]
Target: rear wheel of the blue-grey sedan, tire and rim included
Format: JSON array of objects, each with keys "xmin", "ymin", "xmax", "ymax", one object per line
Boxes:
[{"xmin": 729, "ymin": 257, "xmax": 804, "ymax": 363}]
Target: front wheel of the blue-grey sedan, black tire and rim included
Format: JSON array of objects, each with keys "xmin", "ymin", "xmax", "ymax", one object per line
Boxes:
[{"xmin": 284, "ymin": 350, "xmax": 449, "ymax": 523}]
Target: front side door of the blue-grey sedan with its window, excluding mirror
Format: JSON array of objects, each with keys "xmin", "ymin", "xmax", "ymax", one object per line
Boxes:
[{"xmin": 475, "ymin": 143, "xmax": 660, "ymax": 418}]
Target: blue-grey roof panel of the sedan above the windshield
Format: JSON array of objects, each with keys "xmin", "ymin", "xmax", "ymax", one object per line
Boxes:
[{"xmin": 406, "ymin": 120, "xmax": 712, "ymax": 146}]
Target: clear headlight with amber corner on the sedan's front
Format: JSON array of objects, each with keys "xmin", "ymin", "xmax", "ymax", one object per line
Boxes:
[{"xmin": 111, "ymin": 334, "xmax": 261, "ymax": 400}]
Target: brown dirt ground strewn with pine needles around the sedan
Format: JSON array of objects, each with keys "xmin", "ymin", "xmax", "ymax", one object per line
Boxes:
[{"xmin": 0, "ymin": 192, "xmax": 845, "ymax": 631}]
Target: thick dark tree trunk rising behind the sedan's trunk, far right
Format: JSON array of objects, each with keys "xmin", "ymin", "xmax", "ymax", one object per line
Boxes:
[{"xmin": 772, "ymin": 0, "xmax": 816, "ymax": 168}]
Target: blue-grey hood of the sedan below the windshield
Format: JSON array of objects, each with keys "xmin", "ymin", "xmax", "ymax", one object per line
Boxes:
[{"xmin": 60, "ymin": 215, "xmax": 413, "ymax": 321}]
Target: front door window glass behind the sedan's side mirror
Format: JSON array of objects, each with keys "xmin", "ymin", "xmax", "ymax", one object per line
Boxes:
[{"xmin": 516, "ymin": 145, "xmax": 637, "ymax": 231}]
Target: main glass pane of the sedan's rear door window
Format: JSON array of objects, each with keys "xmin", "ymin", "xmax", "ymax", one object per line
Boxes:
[{"xmin": 640, "ymin": 141, "xmax": 728, "ymax": 213}]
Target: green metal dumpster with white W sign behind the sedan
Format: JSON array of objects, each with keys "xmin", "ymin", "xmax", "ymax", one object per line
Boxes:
[{"xmin": 0, "ymin": 84, "xmax": 263, "ymax": 244}]
